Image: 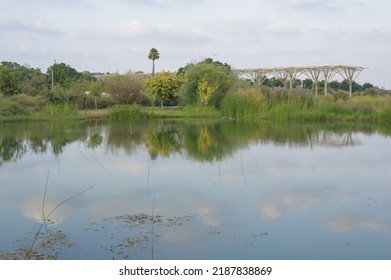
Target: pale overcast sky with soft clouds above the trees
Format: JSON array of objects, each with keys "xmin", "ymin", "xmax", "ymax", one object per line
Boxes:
[{"xmin": 0, "ymin": 0, "xmax": 391, "ymax": 88}]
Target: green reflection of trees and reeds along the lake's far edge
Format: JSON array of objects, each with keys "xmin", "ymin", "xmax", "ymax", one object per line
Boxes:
[{"xmin": 0, "ymin": 120, "xmax": 391, "ymax": 165}]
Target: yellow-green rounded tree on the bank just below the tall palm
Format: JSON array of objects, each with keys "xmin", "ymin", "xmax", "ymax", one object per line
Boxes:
[{"xmin": 145, "ymin": 71, "xmax": 182, "ymax": 108}]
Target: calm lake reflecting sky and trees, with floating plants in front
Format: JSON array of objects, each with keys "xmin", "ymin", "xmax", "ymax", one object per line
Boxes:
[{"xmin": 0, "ymin": 119, "xmax": 391, "ymax": 260}]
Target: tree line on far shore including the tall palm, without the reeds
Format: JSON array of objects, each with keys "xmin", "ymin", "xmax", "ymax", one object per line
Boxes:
[{"xmin": 0, "ymin": 58, "xmax": 388, "ymax": 115}]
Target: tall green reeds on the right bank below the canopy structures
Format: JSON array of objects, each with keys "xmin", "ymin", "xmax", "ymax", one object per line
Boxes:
[{"xmin": 221, "ymin": 89, "xmax": 391, "ymax": 123}]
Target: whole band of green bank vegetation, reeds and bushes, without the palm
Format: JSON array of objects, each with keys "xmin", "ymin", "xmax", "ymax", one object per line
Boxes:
[{"xmin": 0, "ymin": 58, "xmax": 391, "ymax": 122}]
